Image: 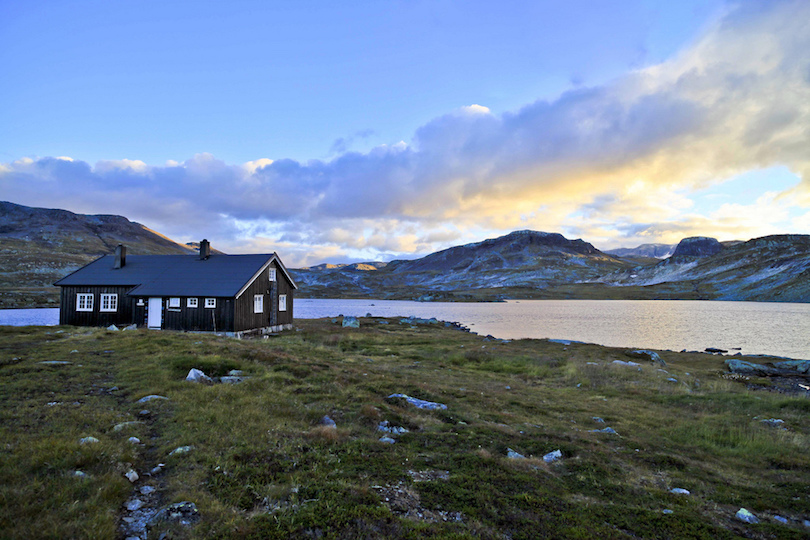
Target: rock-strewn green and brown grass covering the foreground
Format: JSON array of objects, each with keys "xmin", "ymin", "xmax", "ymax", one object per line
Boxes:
[{"xmin": 0, "ymin": 319, "xmax": 810, "ymax": 539}]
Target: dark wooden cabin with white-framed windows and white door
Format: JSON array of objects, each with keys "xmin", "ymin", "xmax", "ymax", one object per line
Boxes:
[{"xmin": 55, "ymin": 240, "xmax": 297, "ymax": 334}]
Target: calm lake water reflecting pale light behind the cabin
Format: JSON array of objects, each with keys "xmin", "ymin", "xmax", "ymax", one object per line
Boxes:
[{"xmin": 0, "ymin": 299, "xmax": 810, "ymax": 359}]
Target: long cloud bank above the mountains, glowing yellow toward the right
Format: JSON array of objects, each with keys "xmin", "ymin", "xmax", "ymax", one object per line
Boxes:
[{"xmin": 0, "ymin": 1, "xmax": 810, "ymax": 263}]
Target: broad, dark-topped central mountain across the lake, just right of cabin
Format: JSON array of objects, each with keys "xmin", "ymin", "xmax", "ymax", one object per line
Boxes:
[{"xmin": 293, "ymin": 231, "xmax": 632, "ymax": 300}]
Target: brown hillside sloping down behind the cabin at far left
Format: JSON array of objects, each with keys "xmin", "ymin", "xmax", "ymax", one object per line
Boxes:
[{"xmin": 0, "ymin": 202, "xmax": 194, "ymax": 308}]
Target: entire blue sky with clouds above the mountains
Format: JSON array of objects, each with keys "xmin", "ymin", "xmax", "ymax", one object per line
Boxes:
[{"xmin": 0, "ymin": 0, "xmax": 810, "ymax": 267}]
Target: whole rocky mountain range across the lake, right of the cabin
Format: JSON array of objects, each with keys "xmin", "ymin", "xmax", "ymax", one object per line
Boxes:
[{"xmin": 293, "ymin": 231, "xmax": 810, "ymax": 302}]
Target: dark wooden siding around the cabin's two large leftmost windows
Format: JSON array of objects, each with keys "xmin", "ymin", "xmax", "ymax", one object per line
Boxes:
[{"xmin": 59, "ymin": 286, "xmax": 133, "ymax": 326}]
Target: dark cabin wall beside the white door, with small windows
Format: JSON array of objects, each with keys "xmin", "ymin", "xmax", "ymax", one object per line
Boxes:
[{"xmin": 133, "ymin": 296, "xmax": 234, "ymax": 332}]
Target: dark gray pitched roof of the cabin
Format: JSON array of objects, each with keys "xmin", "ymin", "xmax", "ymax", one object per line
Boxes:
[{"xmin": 55, "ymin": 253, "xmax": 296, "ymax": 297}]
